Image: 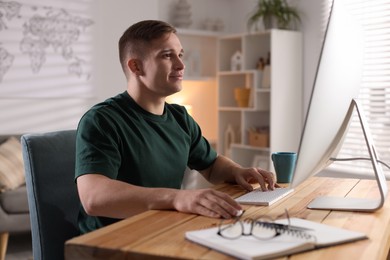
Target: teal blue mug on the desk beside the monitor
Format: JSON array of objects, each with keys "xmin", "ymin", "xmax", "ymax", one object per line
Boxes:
[{"xmin": 271, "ymin": 152, "xmax": 297, "ymax": 183}]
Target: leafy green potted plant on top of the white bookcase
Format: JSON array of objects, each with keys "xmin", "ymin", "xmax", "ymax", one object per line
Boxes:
[{"xmin": 248, "ymin": 0, "xmax": 300, "ymax": 30}]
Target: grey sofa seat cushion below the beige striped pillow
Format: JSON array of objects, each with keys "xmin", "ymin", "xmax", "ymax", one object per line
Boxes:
[{"xmin": 0, "ymin": 185, "xmax": 29, "ymax": 214}]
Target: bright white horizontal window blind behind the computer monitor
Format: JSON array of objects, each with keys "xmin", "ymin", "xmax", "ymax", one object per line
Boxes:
[{"xmin": 324, "ymin": 0, "xmax": 390, "ymax": 174}]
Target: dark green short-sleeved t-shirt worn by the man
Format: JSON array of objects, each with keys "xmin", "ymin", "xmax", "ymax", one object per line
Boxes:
[{"xmin": 75, "ymin": 92, "xmax": 217, "ymax": 233}]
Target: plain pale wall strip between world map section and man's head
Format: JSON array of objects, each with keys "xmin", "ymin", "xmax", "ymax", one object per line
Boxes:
[{"xmin": 95, "ymin": 0, "xmax": 159, "ymax": 101}]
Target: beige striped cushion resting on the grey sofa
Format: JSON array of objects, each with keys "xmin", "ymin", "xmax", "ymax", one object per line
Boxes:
[{"xmin": 0, "ymin": 137, "xmax": 25, "ymax": 192}]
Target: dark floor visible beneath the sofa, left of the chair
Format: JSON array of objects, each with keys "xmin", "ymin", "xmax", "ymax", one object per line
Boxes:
[{"xmin": 5, "ymin": 233, "xmax": 33, "ymax": 260}]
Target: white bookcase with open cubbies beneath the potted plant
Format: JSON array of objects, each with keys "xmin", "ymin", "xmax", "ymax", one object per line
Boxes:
[{"xmin": 217, "ymin": 29, "xmax": 303, "ymax": 170}]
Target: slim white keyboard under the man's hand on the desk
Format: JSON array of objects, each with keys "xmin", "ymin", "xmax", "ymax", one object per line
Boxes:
[{"xmin": 236, "ymin": 188, "xmax": 294, "ymax": 206}]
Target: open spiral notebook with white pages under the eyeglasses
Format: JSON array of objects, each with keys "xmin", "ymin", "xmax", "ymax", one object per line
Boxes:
[{"xmin": 185, "ymin": 218, "xmax": 367, "ymax": 259}]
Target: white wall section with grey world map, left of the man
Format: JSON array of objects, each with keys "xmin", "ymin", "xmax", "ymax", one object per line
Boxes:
[{"xmin": 0, "ymin": 0, "xmax": 102, "ymax": 134}]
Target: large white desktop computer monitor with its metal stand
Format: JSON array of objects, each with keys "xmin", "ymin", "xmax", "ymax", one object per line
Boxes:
[{"xmin": 291, "ymin": 0, "xmax": 387, "ymax": 211}]
